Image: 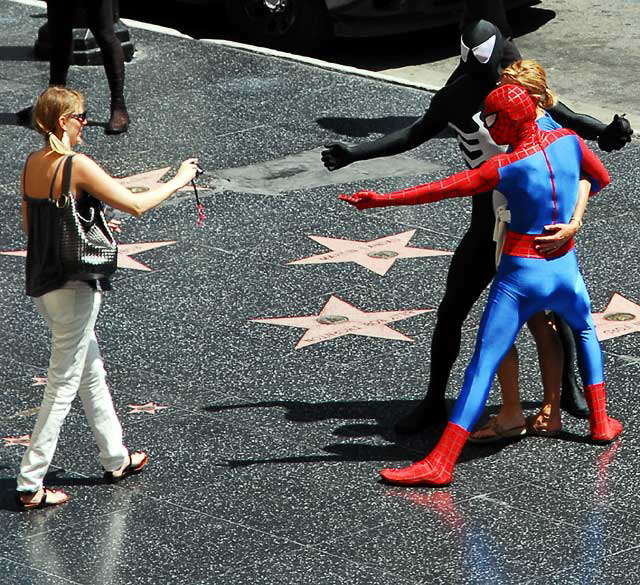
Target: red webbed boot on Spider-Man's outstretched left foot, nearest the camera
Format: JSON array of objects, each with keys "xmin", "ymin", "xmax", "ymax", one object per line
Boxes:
[{"xmin": 380, "ymin": 422, "xmax": 469, "ymax": 486}]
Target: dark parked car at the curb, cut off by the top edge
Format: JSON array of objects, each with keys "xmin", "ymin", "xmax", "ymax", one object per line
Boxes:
[{"xmin": 174, "ymin": 0, "xmax": 537, "ymax": 47}]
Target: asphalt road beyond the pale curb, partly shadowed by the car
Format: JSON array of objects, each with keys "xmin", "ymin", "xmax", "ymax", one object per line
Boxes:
[{"xmin": 121, "ymin": 0, "xmax": 640, "ymax": 126}]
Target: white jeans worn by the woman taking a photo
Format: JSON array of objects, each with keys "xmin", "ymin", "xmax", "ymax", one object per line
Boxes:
[{"xmin": 17, "ymin": 282, "xmax": 129, "ymax": 492}]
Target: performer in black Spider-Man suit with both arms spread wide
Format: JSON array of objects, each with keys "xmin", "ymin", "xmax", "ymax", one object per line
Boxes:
[{"xmin": 322, "ymin": 0, "xmax": 632, "ymax": 432}]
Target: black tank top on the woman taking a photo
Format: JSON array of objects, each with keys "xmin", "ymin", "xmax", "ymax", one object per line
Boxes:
[{"xmin": 22, "ymin": 157, "xmax": 111, "ymax": 297}]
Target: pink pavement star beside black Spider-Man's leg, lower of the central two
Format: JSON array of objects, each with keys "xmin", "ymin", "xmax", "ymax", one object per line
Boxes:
[{"xmin": 250, "ymin": 296, "xmax": 433, "ymax": 349}]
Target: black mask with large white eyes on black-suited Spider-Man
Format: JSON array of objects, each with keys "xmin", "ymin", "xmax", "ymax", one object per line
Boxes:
[{"xmin": 460, "ymin": 20, "xmax": 504, "ymax": 82}]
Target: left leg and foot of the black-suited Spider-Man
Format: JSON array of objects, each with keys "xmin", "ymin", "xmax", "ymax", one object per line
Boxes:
[{"xmin": 395, "ymin": 193, "xmax": 496, "ymax": 433}]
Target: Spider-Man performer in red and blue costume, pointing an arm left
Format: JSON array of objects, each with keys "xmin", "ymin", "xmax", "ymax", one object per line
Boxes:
[{"xmin": 341, "ymin": 85, "xmax": 622, "ymax": 485}]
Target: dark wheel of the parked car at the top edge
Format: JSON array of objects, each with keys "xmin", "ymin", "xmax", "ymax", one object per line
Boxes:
[{"xmin": 226, "ymin": 0, "xmax": 331, "ymax": 49}]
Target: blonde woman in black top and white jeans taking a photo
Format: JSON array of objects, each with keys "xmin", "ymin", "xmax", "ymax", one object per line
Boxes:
[{"xmin": 16, "ymin": 86, "xmax": 198, "ymax": 509}]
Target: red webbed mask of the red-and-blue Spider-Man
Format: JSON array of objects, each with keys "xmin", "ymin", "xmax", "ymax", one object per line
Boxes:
[{"xmin": 482, "ymin": 84, "xmax": 536, "ymax": 146}]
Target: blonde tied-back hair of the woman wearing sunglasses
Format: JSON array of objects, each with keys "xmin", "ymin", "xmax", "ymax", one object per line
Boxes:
[{"xmin": 33, "ymin": 85, "xmax": 84, "ymax": 154}]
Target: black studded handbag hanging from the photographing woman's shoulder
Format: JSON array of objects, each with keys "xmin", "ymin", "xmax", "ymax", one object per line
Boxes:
[{"xmin": 56, "ymin": 156, "xmax": 118, "ymax": 280}]
